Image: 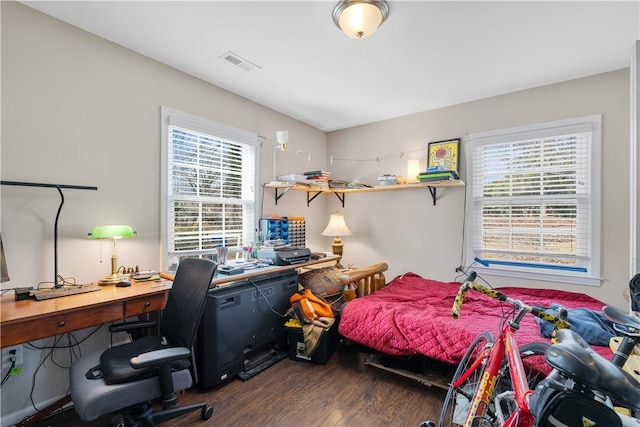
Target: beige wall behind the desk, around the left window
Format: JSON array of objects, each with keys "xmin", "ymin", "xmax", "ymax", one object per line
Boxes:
[{"xmin": 0, "ymin": 2, "xmax": 330, "ymax": 426}]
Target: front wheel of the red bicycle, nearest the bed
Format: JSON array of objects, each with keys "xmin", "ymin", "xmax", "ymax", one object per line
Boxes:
[{"xmin": 438, "ymin": 332, "xmax": 494, "ymax": 427}]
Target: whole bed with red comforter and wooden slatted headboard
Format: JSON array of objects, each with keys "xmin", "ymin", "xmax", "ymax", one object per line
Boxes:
[{"xmin": 340, "ymin": 270, "xmax": 611, "ymax": 388}]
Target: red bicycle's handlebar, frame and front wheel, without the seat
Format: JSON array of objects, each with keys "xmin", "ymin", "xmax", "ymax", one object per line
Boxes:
[{"xmin": 438, "ymin": 272, "xmax": 570, "ymax": 427}]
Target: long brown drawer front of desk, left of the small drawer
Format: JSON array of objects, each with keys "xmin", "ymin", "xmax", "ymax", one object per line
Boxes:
[{"xmin": 2, "ymin": 303, "xmax": 124, "ymax": 346}]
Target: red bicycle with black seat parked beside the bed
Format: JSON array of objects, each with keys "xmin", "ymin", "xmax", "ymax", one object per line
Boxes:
[{"xmin": 421, "ymin": 272, "xmax": 640, "ymax": 427}]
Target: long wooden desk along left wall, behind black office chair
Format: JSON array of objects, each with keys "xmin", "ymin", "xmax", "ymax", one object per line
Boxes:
[{"xmin": 0, "ymin": 256, "xmax": 340, "ymax": 348}]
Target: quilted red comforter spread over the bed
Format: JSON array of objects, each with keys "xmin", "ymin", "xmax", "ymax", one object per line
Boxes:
[{"xmin": 339, "ymin": 273, "xmax": 611, "ymax": 363}]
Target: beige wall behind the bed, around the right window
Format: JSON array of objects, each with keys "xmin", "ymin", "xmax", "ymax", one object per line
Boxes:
[{"xmin": 328, "ymin": 69, "xmax": 629, "ymax": 307}]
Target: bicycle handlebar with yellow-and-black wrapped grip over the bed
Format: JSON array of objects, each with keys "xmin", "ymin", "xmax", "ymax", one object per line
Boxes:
[{"xmin": 451, "ymin": 271, "xmax": 571, "ymax": 340}]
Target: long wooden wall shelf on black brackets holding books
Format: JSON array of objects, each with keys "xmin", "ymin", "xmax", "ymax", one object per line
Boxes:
[{"xmin": 264, "ymin": 179, "xmax": 465, "ymax": 208}]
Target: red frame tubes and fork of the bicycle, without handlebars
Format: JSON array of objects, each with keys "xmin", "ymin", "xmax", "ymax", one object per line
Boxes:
[{"xmin": 452, "ymin": 310, "xmax": 534, "ymax": 427}]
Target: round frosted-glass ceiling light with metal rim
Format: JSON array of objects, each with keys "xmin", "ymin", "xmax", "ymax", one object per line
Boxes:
[{"xmin": 333, "ymin": 0, "xmax": 389, "ymax": 39}]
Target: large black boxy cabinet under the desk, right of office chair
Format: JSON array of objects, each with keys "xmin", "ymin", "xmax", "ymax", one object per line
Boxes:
[{"xmin": 196, "ymin": 270, "xmax": 298, "ymax": 390}]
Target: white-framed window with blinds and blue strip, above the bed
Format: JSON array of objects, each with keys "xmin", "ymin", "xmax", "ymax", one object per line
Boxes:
[{"xmin": 467, "ymin": 116, "xmax": 600, "ymax": 284}]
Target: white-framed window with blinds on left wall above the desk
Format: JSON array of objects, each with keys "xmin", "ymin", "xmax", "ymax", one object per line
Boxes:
[{"xmin": 162, "ymin": 108, "xmax": 258, "ymax": 270}]
